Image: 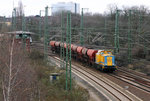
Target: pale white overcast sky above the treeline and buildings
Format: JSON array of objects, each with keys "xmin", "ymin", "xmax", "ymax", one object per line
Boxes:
[{"xmin": 0, "ymin": 0, "xmax": 150, "ymax": 16}]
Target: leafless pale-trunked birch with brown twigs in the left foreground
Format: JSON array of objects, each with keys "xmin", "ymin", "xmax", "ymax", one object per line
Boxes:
[{"xmin": 0, "ymin": 36, "xmax": 35, "ymax": 101}]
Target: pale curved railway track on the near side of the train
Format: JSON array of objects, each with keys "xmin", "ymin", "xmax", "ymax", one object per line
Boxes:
[{"xmin": 54, "ymin": 57, "xmax": 141, "ymax": 101}]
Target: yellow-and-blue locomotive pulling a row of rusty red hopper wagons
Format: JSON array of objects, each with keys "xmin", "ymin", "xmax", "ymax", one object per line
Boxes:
[{"xmin": 49, "ymin": 41, "xmax": 117, "ymax": 72}]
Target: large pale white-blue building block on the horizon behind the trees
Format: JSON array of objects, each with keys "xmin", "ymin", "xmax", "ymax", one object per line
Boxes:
[{"xmin": 51, "ymin": 2, "xmax": 80, "ymax": 15}]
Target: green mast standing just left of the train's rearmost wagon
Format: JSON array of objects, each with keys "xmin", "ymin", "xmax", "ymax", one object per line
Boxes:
[{"xmin": 44, "ymin": 6, "xmax": 48, "ymax": 60}]
